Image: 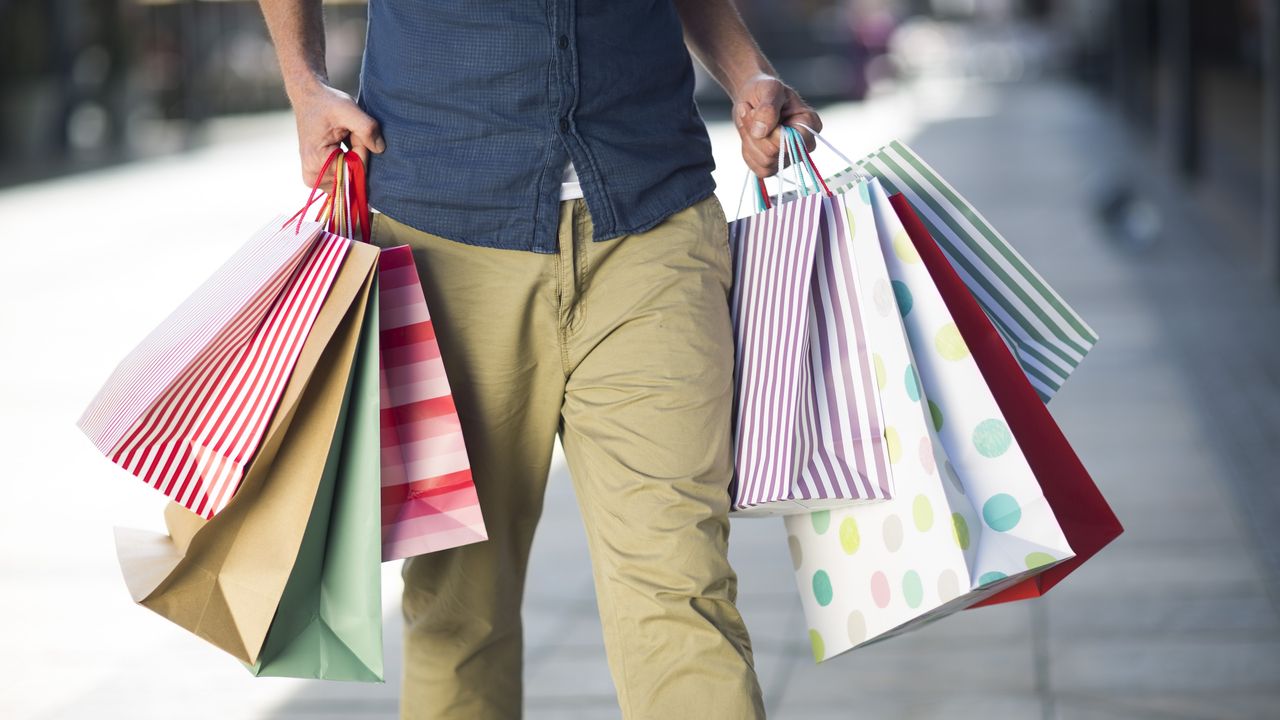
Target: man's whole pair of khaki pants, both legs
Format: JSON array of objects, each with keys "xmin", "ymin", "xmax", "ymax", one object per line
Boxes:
[{"xmin": 372, "ymin": 197, "xmax": 764, "ymax": 720}]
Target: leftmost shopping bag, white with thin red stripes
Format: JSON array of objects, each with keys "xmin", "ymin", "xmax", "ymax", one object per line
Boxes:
[{"xmin": 79, "ymin": 219, "xmax": 351, "ymax": 518}]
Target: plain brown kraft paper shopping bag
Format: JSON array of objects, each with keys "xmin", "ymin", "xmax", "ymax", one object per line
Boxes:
[{"xmin": 116, "ymin": 243, "xmax": 378, "ymax": 664}]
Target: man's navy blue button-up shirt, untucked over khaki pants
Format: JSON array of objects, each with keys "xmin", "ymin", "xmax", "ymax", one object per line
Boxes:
[{"xmin": 360, "ymin": 0, "xmax": 716, "ymax": 252}]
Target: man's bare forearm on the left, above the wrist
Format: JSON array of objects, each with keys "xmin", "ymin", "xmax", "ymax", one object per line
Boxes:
[{"xmin": 259, "ymin": 0, "xmax": 329, "ymax": 104}]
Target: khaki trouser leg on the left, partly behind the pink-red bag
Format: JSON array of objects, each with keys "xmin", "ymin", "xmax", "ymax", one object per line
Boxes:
[{"xmin": 374, "ymin": 210, "xmax": 564, "ymax": 720}]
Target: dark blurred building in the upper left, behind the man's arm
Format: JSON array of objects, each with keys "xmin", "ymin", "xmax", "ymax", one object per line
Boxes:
[{"xmin": 0, "ymin": 0, "xmax": 365, "ymax": 184}]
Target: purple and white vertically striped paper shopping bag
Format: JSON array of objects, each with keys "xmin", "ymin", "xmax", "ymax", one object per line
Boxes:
[{"xmin": 730, "ymin": 196, "xmax": 892, "ymax": 515}]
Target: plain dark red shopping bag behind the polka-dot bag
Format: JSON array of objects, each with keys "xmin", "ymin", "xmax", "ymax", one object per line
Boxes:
[{"xmin": 890, "ymin": 195, "xmax": 1124, "ymax": 605}]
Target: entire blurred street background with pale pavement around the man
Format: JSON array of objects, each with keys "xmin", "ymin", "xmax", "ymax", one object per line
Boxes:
[{"xmin": 0, "ymin": 0, "xmax": 1280, "ymax": 720}]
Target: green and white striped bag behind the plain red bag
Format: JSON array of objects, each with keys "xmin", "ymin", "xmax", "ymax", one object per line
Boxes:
[{"xmin": 827, "ymin": 141, "xmax": 1098, "ymax": 402}]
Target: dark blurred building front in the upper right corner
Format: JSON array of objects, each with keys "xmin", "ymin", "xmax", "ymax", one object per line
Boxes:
[{"xmin": 1052, "ymin": 0, "xmax": 1280, "ymax": 279}]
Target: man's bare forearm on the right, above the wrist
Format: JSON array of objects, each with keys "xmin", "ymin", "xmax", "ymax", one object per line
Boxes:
[{"xmin": 673, "ymin": 0, "xmax": 777, "ymax": 101}]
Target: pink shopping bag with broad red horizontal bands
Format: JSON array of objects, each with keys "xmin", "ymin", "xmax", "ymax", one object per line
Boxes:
[{"xmin": 378, "ymin": 245, "xmax": 489, "ymax": 561}]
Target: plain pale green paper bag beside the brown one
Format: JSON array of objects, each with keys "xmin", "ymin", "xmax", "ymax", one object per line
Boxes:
[{"xmin": 248, "ymin": 274, "xmax": 383, "ymax": 682}]
